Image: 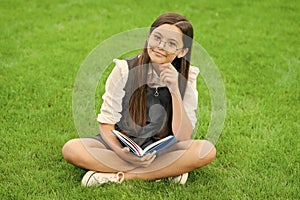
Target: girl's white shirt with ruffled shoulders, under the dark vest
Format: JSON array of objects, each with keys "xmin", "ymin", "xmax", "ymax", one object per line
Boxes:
[{"xmin": 97, "ymin": 59, "xmax": 199, "ymax": 128}]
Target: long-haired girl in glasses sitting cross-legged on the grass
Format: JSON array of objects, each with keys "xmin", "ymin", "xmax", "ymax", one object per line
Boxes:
[{"xmin": 62, "ymin": 13, "xmax": 216, "ymax": 186}]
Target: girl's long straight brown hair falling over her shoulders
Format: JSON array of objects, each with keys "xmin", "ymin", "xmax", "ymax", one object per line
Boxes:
[{"xmin": 128, "ymin": 13, "xmax": 193, "ymax": 134}]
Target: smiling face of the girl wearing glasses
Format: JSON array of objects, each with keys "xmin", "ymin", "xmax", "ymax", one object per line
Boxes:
[{"xmin": 147, "ymin": 24, "xmax": 183, "ymax": 64}]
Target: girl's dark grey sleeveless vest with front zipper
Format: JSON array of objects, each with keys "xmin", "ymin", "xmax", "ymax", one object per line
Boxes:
[{"xmin": 116, "ymin": 56, "xmax": 173, "ymax": 148}]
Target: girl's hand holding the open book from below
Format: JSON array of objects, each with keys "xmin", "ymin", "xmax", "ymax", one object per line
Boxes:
[{"xmin": 122, "ymin": 147, "xmax": 156, "ymax": 167}]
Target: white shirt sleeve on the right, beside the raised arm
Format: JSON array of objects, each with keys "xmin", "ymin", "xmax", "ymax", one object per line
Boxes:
[{"xmin": 183, "ymin": 66, "xmax": 199, "ymax": 128}]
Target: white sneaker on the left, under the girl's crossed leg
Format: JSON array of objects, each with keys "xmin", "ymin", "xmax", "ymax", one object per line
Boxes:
[{"xmin": 81, "ymin": 171, "xmax": 124, "ymax": 186}]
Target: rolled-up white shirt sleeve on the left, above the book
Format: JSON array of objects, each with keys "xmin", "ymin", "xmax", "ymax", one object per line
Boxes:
[{"xmin": 97, "ymin": 59, "xmax": 128, "ymax": 124}]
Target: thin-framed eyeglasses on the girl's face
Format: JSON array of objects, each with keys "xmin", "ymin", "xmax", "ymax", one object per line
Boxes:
[{"xmin": 148, "ymin": 34, "xmax": 183, "ymax": 53}]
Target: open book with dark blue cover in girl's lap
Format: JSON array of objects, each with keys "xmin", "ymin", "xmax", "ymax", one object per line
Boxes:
[{"xmin": 112, "ymin": 130, "xmax": 177, "ymax": 157}]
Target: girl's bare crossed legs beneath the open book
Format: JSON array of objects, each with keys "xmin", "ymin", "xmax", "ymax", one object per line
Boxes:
[{"xmin": 62, "ymin": 138, "xmax": 216, "ymax": 180}]
